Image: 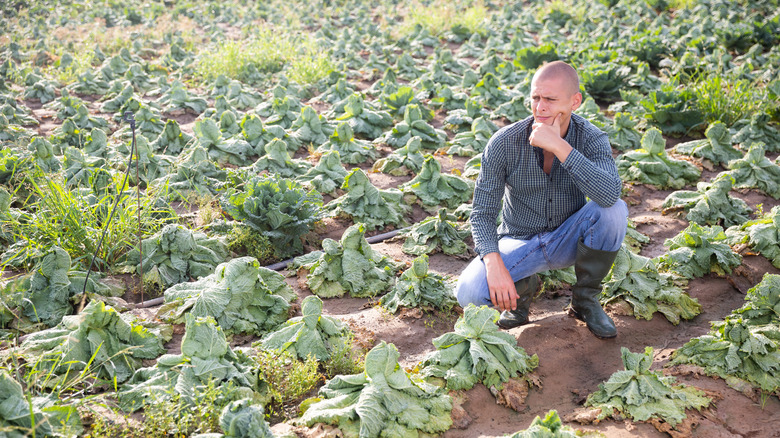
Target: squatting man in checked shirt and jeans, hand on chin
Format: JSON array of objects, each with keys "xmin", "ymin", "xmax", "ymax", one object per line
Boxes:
[{"xmin": 456, "ymin": 61, "xmax": 628, "ymax": 338}]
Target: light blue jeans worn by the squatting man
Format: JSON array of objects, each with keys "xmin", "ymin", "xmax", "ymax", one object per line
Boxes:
[{"xmin": 455, "ymin": 199, "xmax": 628, "ymax": 307}]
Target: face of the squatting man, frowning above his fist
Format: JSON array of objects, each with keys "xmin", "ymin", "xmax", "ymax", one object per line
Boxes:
[{"xmin": 531, "ymin": 77, "xmax": 582, "ymax": 128}]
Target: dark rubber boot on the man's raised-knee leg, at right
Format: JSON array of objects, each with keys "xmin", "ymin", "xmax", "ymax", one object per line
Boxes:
[{"xmin": 571, "ymin": 239, "xmax": 617, "ymax": 338}]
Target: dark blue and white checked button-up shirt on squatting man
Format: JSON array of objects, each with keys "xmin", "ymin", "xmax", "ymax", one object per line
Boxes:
[{"xmin": 470, "ymin": 114, "xmax": 622, "ymax": 257}]
